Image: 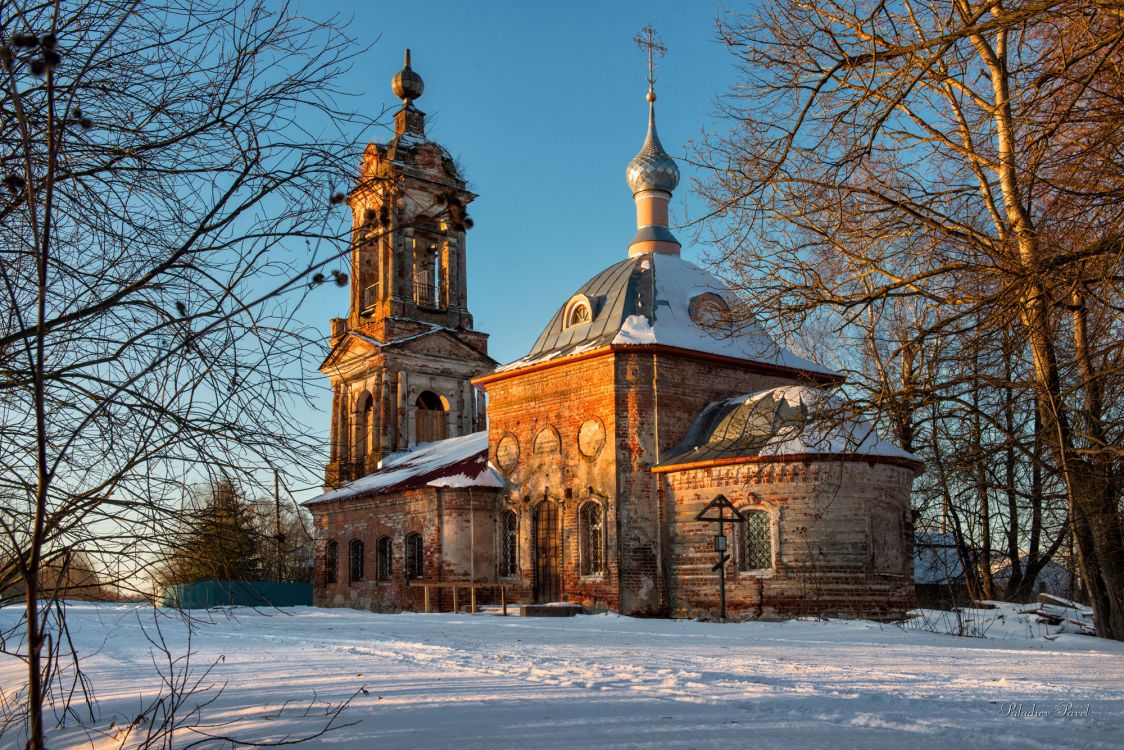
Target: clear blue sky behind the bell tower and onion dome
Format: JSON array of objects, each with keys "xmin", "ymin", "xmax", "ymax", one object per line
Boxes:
[{"xmin": 285, "ymin": 0, "xmax": 736, "ymax": 499}]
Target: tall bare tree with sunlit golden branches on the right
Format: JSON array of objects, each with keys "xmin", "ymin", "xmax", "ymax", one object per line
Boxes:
[{"xmin": 699, "ymin": 0, "xmax": 1124, "ymax": 639}]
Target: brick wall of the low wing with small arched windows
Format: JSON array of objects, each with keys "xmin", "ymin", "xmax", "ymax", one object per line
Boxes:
[{"xmin": 310, "ymin": 488, "xmax": 498, "ymax": 612}]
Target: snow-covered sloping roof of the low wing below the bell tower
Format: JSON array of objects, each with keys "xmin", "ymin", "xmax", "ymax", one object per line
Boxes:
[{"xmin": 303, "ymin": 432, "xmax": 504, "ymax": 505}]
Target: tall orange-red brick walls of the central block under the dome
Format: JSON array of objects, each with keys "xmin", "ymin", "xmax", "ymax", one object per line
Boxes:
[{"xmin": 478, "ymin": 349, "xmax": 822, "ymax": 616}]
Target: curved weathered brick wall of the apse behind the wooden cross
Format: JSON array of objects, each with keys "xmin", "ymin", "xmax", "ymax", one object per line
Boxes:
[{"xmin": 663, "ymin": 461, "xmax": 914, "ymax": 618}]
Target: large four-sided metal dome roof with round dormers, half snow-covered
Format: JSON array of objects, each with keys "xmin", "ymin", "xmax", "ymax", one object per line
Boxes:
[{"xmin": 497, "ymin": 254, "xmax": 836, "ymax": 376}]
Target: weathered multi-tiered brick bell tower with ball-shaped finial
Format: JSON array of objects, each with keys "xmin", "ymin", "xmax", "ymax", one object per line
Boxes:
[{"xmin": 320, "ymin": 49, "xmax": 496, "ymax": 488}]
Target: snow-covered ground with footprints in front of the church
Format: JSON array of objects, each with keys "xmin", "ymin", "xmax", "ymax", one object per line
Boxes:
[{"xmin": 0, "ymin": 604, "xmax": 1124, "ymax": 750}]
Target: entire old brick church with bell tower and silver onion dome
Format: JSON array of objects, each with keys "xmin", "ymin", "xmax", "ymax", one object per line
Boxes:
[{"xmin": 306, "ymin": 52, "xmax": 921, "ymax": 617}]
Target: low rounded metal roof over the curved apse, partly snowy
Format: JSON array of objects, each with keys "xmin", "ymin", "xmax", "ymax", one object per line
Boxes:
[{"xmin": 660, "ymin": 386, "xmax": 921, "ymax": 467}]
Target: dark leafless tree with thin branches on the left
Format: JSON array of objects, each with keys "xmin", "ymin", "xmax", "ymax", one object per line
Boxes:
[{"xmin": 0, "ymin": 0, "xmax": 382, "ymax": 748}]
